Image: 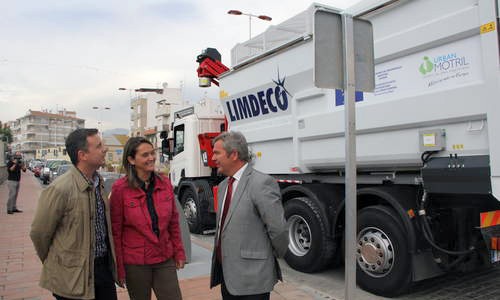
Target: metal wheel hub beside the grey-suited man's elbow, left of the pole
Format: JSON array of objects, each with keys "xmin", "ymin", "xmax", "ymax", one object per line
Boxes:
[{"xmin": 287, "ymin": 215, "xmax": 312, "ymax": 256}]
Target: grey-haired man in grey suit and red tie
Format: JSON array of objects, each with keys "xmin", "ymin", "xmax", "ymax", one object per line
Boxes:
[{"xmin": 210, "ymin": 132, "xmax": 288, "ymax": 300}]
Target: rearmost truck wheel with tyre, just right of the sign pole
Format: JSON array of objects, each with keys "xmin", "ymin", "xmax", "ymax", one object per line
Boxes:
[{"xmin": 356, "ymin": 205, "xmax": 412, "ymax": 297}]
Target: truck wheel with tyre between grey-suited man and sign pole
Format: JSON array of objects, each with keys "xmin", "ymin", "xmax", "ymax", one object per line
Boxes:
[{"xmin": 284, "ymin": 197, "xmax": 334, "ymax": 273}]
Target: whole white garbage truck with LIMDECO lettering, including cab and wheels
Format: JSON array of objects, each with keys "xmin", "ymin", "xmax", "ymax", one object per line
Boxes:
[{"xmin": 168, "ymin": 0, "xmax": 500, "ymax": 297}]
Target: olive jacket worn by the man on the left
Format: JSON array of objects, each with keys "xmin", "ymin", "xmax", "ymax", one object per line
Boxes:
[{"xmin": 30, "ymin": 166, "xmax": 116, "ymax": 299}]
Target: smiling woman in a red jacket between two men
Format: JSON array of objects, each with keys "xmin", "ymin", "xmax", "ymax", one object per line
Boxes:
[{"xmin": 110, "ymin": 137, "xmax": 186, "ymax": 300}]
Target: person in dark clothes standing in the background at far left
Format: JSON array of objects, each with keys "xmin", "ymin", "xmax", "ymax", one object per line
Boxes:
[{"xmin": 7, "ymin": 152, "xmax": 26, "ymax": 214}]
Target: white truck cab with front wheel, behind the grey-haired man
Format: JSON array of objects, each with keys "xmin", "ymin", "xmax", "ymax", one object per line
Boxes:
[{"xmin": 169, "ymin": 99, "xmax": 225, "ymax": 233}]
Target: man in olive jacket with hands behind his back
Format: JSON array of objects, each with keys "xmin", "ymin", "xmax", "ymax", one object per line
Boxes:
[{"xmin": 30, "ymin": 129, "xmax": 117, "ymax": 300}]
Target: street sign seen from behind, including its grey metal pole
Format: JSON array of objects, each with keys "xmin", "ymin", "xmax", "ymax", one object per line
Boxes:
[{"xmin": 313, "ymin": 9, "xmax": 375, "ymax": 300}]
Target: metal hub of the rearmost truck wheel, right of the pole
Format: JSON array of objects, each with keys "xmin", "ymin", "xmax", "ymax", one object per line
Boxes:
[{"xmin": 356, "ymin": 227, "xmax": 394, "ymax": 277}]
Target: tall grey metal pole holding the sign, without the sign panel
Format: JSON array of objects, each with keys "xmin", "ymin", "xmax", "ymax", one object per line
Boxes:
[{"xmin": 342, "ymin": 14, "xmax": 357, "ymax": 300}]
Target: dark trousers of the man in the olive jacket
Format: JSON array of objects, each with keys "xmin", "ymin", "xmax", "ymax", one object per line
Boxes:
[{"xmin": 53, "ymin": 258, "xmax": 117, "ymax": 300}]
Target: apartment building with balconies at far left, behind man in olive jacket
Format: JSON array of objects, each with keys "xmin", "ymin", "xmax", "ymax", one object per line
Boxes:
[{"xmin": 9, "ymin": 110, "xmax": 85, "ymax": 158}]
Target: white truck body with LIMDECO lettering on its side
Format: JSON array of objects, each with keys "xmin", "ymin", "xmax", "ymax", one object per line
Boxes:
[{"xmin": 220, "ymin": 0, "xmax": 500, "ymax": 199}]
